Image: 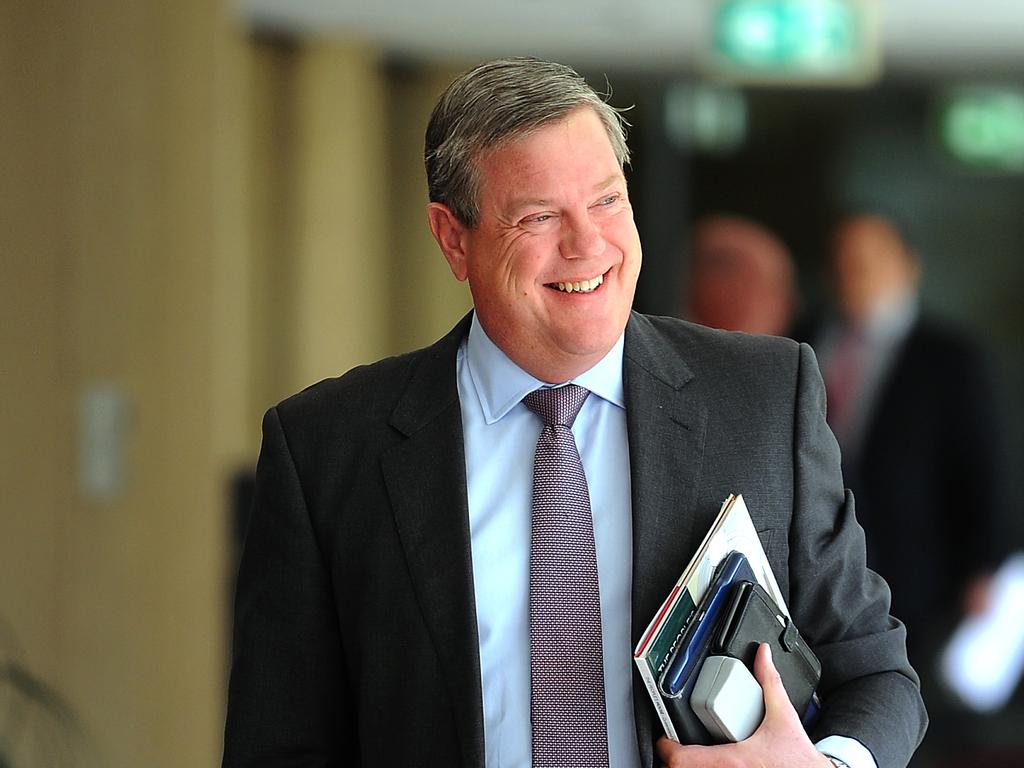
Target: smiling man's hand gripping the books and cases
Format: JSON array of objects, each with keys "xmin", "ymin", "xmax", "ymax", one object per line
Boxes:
[{"xmin": 657, "ymin": 643, "xmax": 833, "ymax": 768}]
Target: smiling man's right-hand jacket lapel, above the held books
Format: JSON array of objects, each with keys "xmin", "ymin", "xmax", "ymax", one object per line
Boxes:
[{"xmin": 623, "ymin": 313, "xmax": 708, "ymax": 765}]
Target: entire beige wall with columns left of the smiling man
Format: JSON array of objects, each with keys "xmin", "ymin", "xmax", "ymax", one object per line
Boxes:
[{"xmin": 0, "ymin": 0, "xmax": 468, "ymax": 768}]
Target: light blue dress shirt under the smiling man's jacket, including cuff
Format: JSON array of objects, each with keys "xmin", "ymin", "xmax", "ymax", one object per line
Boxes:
[{"xmin": 456, "ymin": 313, "xmax": 877, "ymax": 768}]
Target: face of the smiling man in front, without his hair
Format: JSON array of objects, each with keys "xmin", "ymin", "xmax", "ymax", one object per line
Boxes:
[{"xmin": 432, "ymin": 108, "xmax": 640, "ymax": 383}]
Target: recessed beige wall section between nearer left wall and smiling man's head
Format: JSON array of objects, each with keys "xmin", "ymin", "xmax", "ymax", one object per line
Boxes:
[{"xmin": 250, "ymin": 40, "xmax": 471, "ymax": 415}]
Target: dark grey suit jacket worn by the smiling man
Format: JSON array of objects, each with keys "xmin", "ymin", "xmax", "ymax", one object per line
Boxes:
[{"xmin": 223, "ymin": 313, "xmax": 926, "ymax": 768}]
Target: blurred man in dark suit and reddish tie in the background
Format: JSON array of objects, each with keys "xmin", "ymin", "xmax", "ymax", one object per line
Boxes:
[{"xmin": 798, "ymin": 215, "xmax": 1000, "ymax": 667}]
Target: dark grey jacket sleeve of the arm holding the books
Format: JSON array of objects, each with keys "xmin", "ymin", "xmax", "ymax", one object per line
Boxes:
[{"xmin": 790, "ymin": 344, "xmax": 928, "ymax": 768}]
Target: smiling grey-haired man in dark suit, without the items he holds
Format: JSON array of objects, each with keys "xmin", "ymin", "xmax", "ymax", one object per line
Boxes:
[{"xmin": 224, "ymin": 58, "xmax": 926, "ymax": 768}]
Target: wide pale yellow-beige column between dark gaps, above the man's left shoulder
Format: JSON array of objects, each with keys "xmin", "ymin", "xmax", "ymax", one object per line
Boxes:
[{"xmin": 288, "ymin": 41, "xmax": 394, "ymax": 391}]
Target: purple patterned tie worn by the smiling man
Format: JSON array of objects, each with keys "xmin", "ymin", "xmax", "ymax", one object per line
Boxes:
[{"xmin": 522, "ymin": 384, "xmax": 608, "ymax": 768}]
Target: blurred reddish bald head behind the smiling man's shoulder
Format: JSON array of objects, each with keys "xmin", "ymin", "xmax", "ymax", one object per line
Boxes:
[{"xmin": 684, "ymin": 215, "xmax": 797, "ymax": 336}]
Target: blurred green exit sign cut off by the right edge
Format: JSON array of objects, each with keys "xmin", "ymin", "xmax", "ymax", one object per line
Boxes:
[{"xmin": 938, "ymin": 87, "xmax": 1024, "ymax": 172}]
